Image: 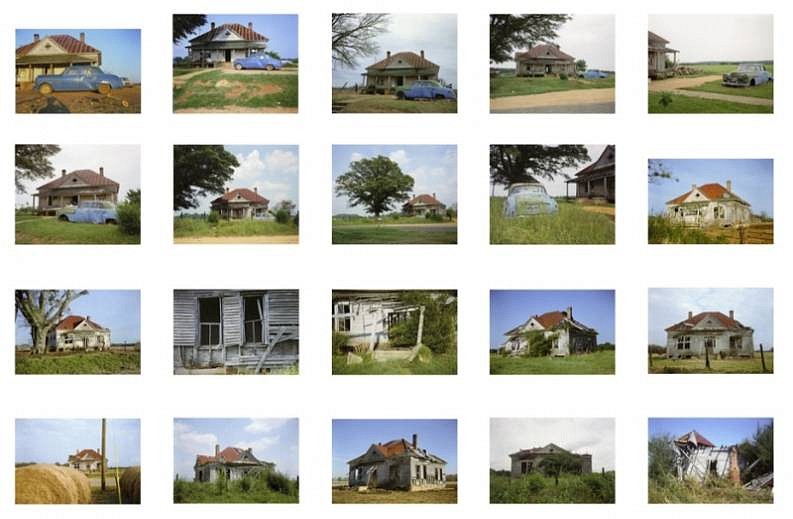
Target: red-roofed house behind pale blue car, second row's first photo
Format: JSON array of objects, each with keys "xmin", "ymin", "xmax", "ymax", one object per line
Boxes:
[{"xmin": 33, "ymin": 167, "xmax": 119, "ymax": 215}]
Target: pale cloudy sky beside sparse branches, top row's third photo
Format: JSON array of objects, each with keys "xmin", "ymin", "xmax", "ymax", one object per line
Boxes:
[{"xmin": 328, "ymin": 13, "xmax": 458, "ymax": 88}]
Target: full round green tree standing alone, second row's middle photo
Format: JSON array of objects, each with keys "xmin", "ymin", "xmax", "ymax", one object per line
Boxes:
[{"xmin": 336, "ymin": 155, "xmax": 413, "ymax": 217}]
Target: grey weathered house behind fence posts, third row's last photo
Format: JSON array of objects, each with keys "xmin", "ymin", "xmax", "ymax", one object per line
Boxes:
[{"xmin": 665, "ymin": 310, "xmax": 754, "ymax": 359}]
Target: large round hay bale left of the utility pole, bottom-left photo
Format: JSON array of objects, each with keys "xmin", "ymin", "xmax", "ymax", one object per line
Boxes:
[{"xmin": 15, "ymin": 465, "xmax": 91, "ymax": 505}]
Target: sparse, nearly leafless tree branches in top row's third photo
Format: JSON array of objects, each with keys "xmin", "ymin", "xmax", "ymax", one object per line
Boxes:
[{"xmin": 330, "ymin": 13, "xmax": 388, "ymax": 68}]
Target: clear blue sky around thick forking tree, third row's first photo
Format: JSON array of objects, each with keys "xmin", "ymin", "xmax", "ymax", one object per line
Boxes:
[{"xmin": 16, "ymin": 290, "xmax": 140, "ymax": 344}]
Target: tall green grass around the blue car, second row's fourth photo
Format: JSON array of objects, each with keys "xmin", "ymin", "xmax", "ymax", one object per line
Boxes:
[{"xmin": 490, "ymin": 197, "xmax": 614, "ymax": 244}]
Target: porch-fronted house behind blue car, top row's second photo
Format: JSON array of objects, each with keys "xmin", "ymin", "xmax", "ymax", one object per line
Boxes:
[{"xmin": 187, "ymin": 22, "xmax": 270, "ymax": 68}]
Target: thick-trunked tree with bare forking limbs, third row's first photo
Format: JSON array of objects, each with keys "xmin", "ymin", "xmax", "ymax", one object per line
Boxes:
[{"xmin": 14, "ymin": 290, "xmax": 88, "ymax": 353}]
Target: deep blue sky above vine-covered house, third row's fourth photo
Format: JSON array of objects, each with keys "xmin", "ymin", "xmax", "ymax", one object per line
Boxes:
[{"xmin": 490, "ymin": 290, "xmax": 614, "ymax": 348}]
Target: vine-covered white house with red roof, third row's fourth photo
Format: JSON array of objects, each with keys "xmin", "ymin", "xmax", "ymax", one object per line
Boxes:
[{"xmin": 503, "ymin": 306, "xmax": 598, "ymax": 357}]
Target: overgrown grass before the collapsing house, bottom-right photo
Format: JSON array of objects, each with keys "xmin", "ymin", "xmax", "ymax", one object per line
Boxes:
[{"xmin": 647, "ymin": 477, "xmax": 774, "ymax": 504}]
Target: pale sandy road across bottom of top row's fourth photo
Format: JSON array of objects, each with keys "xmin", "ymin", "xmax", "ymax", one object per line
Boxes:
[{"xmin": 490, "ymin": 88, "xmax": 614, "ymax": 113}]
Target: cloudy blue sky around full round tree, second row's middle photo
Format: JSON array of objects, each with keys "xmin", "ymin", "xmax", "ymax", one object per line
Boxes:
[{"xmin": 331, "ymin": 144, "xmax": 457, "ymax": 215}]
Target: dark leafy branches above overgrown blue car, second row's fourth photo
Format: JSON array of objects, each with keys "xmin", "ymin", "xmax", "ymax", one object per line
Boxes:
[{"xmin": 490, "ymin": 144, "xmax": 590, "ymax": 186}]
